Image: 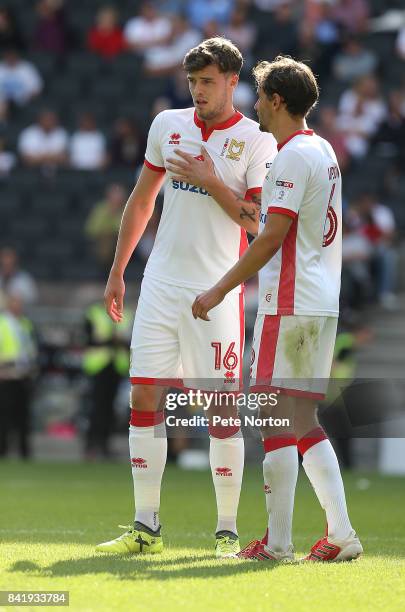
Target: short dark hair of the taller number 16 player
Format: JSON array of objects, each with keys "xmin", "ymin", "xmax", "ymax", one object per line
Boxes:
[{"xmin": 183, "ymin": 36, "xmax": 243, "ymax": 74}]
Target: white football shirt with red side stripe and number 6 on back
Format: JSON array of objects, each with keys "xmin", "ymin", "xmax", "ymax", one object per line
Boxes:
[{"xmin": 258, "ymin": 130, "xmax": 342, "ymax": 317}]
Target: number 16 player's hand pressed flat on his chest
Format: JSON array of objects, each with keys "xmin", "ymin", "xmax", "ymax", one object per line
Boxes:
[{"xmin": 166, "ymin": 147, "xmax": 215, "ymax": 190}]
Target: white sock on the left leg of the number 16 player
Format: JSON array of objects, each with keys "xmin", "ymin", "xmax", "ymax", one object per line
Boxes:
[{"xmin": 129, "ymin": 423, "xmax": 167, "ymax": 531}]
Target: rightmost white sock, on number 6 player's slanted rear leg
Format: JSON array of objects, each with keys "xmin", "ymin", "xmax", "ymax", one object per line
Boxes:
[{"xmin": 302, "ymin": 440, "xmax": 353, "ymax": 540}]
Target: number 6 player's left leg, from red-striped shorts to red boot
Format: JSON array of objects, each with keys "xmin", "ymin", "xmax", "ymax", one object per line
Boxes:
[{"xmin": 240, "ymin": 315, "xmax": 298, "ymax": 560}]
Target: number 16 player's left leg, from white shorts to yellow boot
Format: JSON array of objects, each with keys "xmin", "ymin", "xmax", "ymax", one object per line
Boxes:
[{"xmin": 97, "ymin": 279, "xmax": 180, "ymax": 553}]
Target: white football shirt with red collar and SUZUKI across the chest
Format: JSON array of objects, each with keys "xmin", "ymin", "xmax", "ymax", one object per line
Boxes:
[{"xmin": 144, "ymin": 108, "xmax": 277, "ymax": 290}]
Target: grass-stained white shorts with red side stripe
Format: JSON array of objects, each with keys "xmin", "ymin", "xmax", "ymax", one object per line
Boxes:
[{"xmin": 250, "ymin": 314, "xmax": 338, "ymax": 400}]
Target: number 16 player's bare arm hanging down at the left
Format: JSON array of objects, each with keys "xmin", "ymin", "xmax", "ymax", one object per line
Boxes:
[{"xmin": 104, "ymin": 166, "xmax": 165, "ymax": 323}]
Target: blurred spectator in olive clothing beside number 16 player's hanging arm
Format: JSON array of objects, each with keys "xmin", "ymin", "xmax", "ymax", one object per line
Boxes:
[{"xmin": 84, "ymin": 184, "xmax": 127, "ymax": 270}]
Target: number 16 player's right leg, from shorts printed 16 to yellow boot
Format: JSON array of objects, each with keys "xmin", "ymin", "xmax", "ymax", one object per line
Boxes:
[{"xmin": 180, "ymin": 291, "xmax": 245, "ymax": 557}]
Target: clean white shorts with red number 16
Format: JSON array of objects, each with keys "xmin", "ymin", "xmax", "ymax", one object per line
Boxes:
[{"xmin": 130, "ymin": 278, "xmax": 245, "ymax": 391}]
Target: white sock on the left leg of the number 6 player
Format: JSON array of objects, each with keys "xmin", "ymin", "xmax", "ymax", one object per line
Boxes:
[{"xmin": 263, "ymin": 444, "xmax": 298, "ymax": 552}]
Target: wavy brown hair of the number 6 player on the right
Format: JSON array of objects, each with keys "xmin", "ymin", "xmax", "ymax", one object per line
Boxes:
[{"xmin": 253, "ymin": 55, "xmax": 319, "ymax": 117}]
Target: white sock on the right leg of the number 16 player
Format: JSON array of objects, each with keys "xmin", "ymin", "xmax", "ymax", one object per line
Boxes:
[{"xmin": 210, "ymin": 431, "xmax": 245, "ymax": 534}]
